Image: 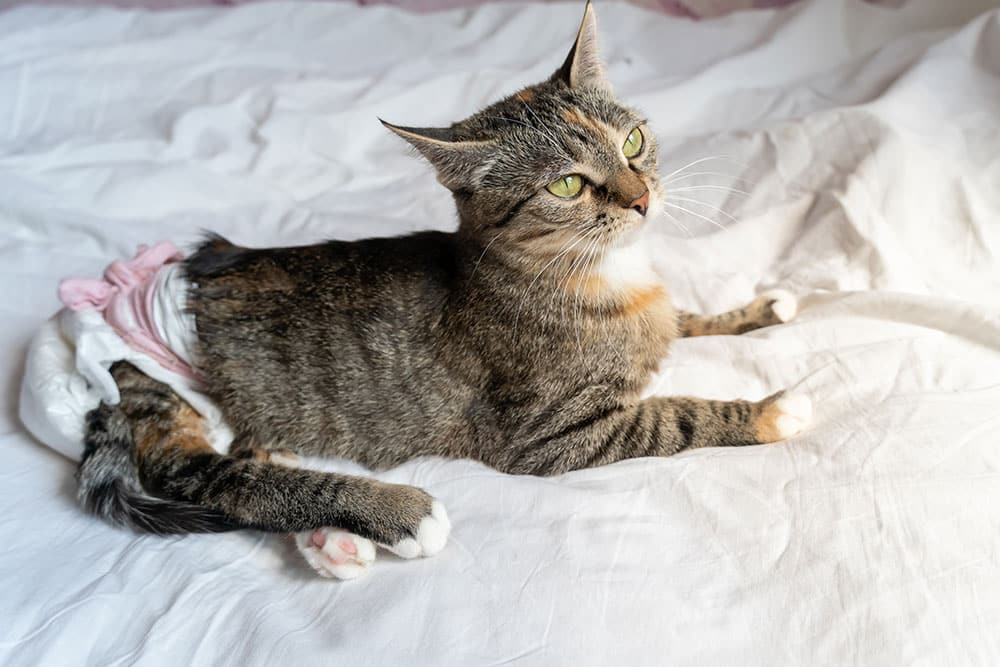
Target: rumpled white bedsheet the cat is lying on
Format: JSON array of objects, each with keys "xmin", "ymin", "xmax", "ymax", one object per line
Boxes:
[{"xmin": 0, "ymin": 0, "xmax": 1000, "ymax": 665}]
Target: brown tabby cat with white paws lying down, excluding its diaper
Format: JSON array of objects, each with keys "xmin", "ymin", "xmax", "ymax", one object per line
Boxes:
[{"xmin": 77, "ymin": 2, "xmax": 811, "ymax": 578}]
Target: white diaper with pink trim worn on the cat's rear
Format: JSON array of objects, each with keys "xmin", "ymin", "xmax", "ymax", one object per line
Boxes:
[{"xmin": 19, "ymin": 242, "xmax": 232, "ymax": 460}]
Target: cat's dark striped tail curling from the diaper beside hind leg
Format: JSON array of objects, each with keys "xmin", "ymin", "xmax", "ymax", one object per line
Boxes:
[{"xmin": 76, "ymin": 404, "xmax": 246, "ymax": 535}]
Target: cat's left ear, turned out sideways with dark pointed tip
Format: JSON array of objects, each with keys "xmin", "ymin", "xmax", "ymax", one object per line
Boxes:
[{"xmin": 379, "ymin": 118, "xmax": 495, "ymax": 191}]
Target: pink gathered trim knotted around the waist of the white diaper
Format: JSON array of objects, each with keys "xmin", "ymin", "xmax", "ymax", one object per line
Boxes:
[{"xmin": 59, "ymin": 241, "xmax": 195, "ymax": 379}]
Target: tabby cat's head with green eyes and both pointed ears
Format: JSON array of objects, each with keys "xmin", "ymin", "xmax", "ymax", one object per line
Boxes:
[{"xmin": 385, "ymin": 2, "xmax": 661, "ymax": 264}]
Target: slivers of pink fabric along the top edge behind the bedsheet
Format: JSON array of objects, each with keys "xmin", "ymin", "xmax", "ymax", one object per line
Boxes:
[{"xmin": 0, "ymin": 0, "xmax": 905, "ymax": 19}]
